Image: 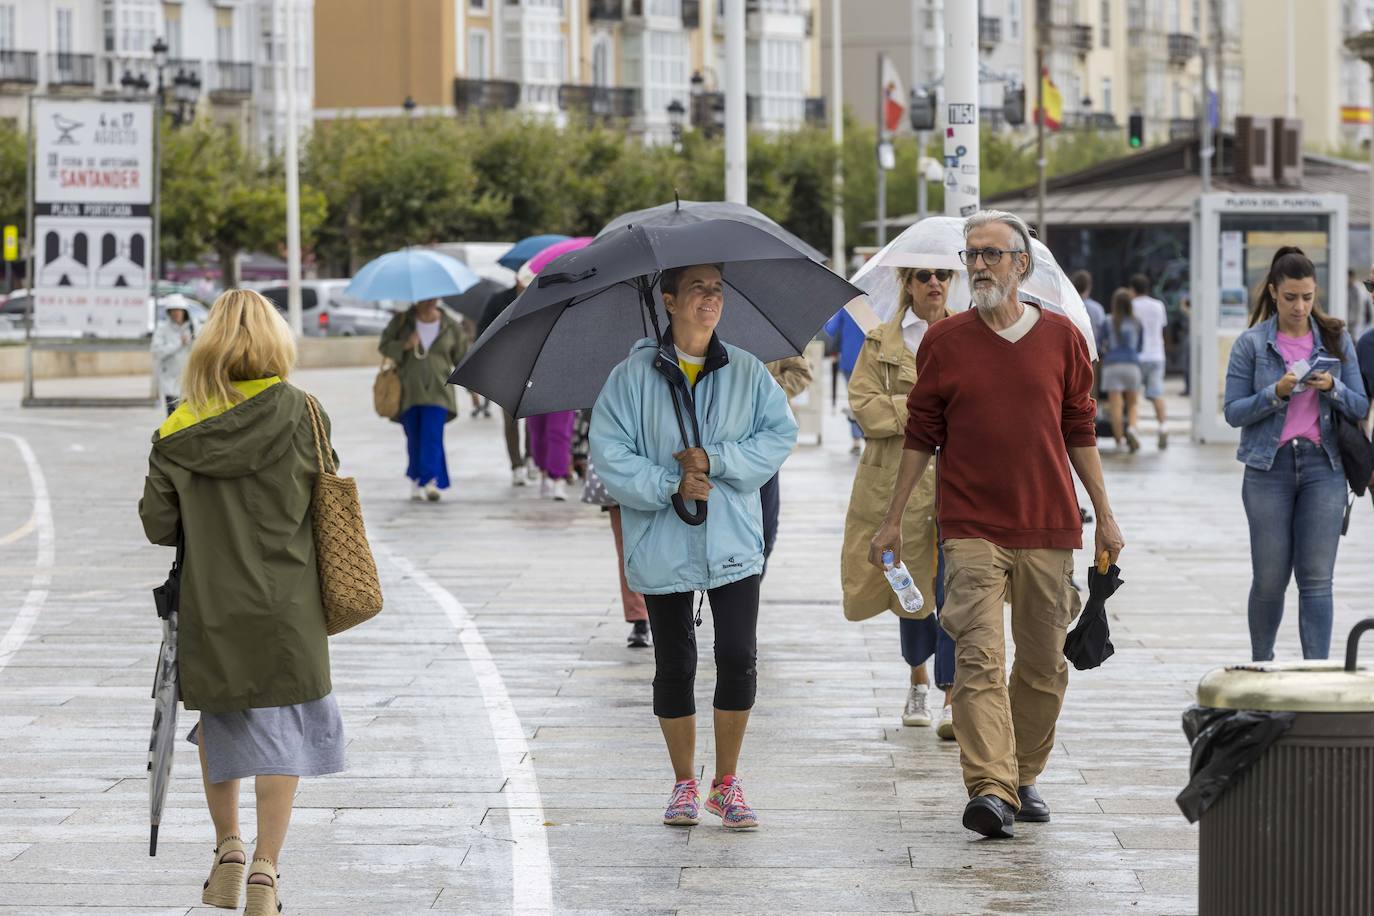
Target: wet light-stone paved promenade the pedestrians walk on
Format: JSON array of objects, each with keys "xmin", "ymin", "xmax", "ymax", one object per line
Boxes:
[{"xmin": 0, "ymin": 369, "xmax": 1374, "ymax": 916}]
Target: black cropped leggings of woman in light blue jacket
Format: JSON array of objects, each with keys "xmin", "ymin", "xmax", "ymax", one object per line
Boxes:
[{"xmin": 644, "ymin": 575, "xmax": 760, "ymax": 718}]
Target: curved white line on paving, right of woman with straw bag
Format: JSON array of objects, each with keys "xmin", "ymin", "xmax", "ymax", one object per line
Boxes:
[{"xmin": 372, "ymin": 541, "xmax": 554, "ymax": 913}]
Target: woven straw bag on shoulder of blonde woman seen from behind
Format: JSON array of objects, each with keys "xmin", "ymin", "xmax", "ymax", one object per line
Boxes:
[{"xmin": 305, "ymin": 394, "xmax": 382, "ymax": 636}]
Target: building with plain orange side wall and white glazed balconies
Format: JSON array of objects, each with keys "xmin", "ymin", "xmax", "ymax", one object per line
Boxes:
[{"xmin": 315, "ymin": 0, "xmax": 824, "ymax": 140}]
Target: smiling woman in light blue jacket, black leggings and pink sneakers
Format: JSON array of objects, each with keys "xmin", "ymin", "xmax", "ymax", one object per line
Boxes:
[{"xmin": 591, "ymin": 265, "xmax": 797, "ymax": 828}]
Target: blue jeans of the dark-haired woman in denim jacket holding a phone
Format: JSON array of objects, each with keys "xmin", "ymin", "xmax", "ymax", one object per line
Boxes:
[{"xmin": 1241, "ymin": 438, "xmax": 1345, "ymax": 662}]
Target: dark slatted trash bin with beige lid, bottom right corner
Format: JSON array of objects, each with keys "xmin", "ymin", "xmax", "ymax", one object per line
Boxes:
[{"xmin": 1194, "ymin": 618, "xmax": 1374, "ymax": 916}]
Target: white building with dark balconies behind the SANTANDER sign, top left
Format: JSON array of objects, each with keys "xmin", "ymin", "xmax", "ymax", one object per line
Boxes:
[{"xmin": 0, "ymin": 0, "xmax": 313, "ymax": 151}]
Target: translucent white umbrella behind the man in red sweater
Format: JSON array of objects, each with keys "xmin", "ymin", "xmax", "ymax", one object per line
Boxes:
[{"xmin": 849, "ymin": 216, "xmax": 1098, "ymax": 360}]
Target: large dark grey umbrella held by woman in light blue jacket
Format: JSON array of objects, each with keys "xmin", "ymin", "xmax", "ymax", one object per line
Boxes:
[{"xmin": 449, "ymin": 220, "xmax": 863, "ymax": 523}]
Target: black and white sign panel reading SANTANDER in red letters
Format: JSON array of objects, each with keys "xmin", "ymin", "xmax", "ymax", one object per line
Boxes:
[{"xmin": 30, "ymin": 98, "xmax": 154, "ymax": 339}]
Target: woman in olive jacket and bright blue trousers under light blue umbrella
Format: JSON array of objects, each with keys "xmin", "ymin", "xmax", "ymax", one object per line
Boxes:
[{"xmin": 376, "ymin": 299, "xmax": 471, "ymax": 503}]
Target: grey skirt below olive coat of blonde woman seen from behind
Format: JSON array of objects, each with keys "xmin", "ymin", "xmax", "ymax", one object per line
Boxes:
[{"xmin": 185, "ymin": 694, "xmax": 345, "ymax": 783}]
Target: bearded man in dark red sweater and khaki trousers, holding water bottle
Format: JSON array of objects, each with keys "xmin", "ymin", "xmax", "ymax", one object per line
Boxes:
[{"xmin": 870, "ymin": 210, "xmax": 1124, "ymax": 838}]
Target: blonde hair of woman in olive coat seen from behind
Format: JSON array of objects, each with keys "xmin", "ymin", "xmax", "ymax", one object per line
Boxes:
[{"xmin": 181, "ymin": 290, "xmax": 295, "ymax": 413}]
